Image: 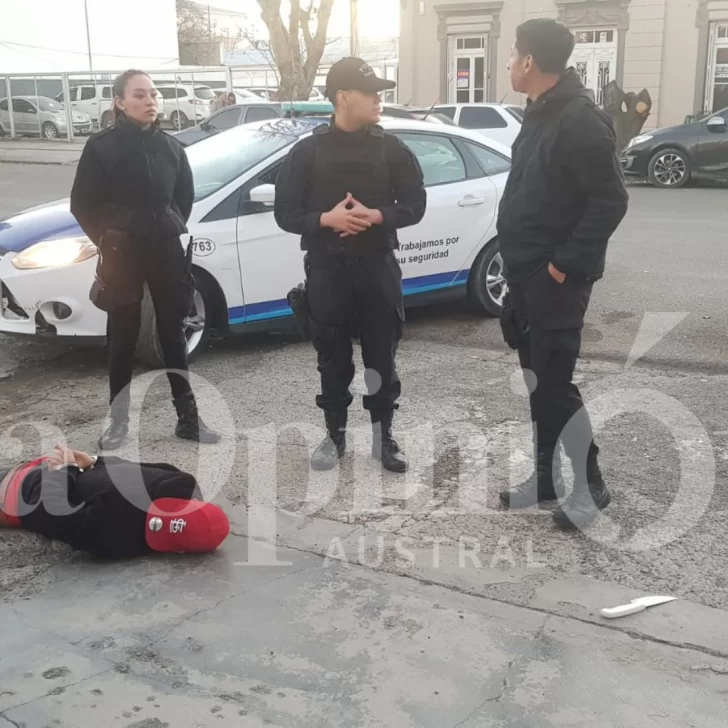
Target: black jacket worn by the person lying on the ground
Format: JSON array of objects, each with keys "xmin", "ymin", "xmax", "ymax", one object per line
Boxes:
[{"xmin": 18, "ymin": 457, "xmax": 201, "ymax": 558}]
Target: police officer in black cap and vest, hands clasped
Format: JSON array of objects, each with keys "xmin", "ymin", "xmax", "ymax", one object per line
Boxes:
[{"xmin": 275, "ymin": 58, "xmax": 427, "ymax": 472}]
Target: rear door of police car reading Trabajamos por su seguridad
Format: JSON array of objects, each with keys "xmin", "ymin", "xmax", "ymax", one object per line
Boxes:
[{"xmin": 394, "ymin": 131, "xmax": 498, "ymax": 294}]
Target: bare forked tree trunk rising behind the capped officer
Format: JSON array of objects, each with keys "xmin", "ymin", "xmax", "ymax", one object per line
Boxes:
[{"xmin": 258, "ymin": 0, "xmax": 336, "ymax": 101}]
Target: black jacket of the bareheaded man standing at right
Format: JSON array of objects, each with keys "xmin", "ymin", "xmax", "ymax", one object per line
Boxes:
[{"xmin": 498, "ymin": 69, "xmax": 628, "ymax": 281}]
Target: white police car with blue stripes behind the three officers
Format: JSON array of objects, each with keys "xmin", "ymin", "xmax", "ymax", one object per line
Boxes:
[{"xmin": 0, "ymin": 119, "xmax": 510, "ymax": 365}]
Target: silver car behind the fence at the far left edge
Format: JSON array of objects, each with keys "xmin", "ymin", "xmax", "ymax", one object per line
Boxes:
[{"xmin": 0, "ymin": 96, "xmax": 92, "ymax": 139}]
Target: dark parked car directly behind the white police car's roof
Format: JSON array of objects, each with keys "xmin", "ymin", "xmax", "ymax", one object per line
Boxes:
[{"xmin": 173, "ymin": 101, "xmax": 454, "ymax": 147}]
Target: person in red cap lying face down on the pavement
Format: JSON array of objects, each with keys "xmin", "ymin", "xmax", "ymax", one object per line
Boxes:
[{"xmin": 0, "ymin": 445, "xmax": 230, "ymax": 559}]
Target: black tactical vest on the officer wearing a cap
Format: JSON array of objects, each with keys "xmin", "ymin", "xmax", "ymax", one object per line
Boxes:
[{"xmin": 309, "ymin": 126, "xmax": 397, "ymax": 255}]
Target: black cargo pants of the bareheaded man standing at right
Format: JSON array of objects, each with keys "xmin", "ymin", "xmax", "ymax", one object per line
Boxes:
[{"xmin": 509, "ymin": 266, "xmax": 593, "ymax": 461}]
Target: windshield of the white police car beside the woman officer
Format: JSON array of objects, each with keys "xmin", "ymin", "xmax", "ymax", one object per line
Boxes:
[{"xmin": 186, "ymin": 119, "xmax": 313, "ymax": 202}]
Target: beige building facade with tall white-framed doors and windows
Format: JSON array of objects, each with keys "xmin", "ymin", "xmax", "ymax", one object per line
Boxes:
[{"xmin": 399, "ymin": 0, "xmax": 728, "ymax": 128}]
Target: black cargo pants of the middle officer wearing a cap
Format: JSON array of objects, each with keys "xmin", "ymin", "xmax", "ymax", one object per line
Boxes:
[{"xmin": 306, "ymin": 252, "xmax": 404, "ymax": 421}]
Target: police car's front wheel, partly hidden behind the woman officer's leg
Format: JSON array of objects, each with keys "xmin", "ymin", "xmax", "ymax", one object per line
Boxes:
[{"xmin": 136, "ymin": 275, "xmax": 213, "ymax": 368}]
